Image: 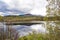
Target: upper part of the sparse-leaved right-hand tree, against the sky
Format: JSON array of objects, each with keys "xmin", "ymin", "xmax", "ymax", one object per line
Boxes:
[{"xmin": 47, "ymin": 0, "xmax": 60, "ymax": 16}]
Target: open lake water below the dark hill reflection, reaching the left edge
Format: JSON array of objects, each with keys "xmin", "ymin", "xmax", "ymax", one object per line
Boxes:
[{"xmin": 0, "ymin": 22, "xmax": 46, "ymax": 36}]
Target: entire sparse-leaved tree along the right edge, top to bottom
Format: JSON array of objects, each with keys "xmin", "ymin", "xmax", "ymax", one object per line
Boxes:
[{"xmin": 47, "ymin": 0, "xmax": 60, "ymax": 40}]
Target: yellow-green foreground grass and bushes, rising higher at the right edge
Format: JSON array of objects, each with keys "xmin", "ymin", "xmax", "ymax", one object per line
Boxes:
[{"xmin": 19, "ymin": 26, "xmax": 60, "ymax": 40}]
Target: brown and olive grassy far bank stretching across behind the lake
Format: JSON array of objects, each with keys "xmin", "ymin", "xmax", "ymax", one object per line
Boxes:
[{"xmin": 0, "ymin": 16, "xmax": 60, "ymax": 22}]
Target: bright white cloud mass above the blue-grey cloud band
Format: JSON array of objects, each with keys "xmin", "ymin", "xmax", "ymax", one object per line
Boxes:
[{"xmin": 0, "ymin": 0, "xmax": 47, "ymax": 16}]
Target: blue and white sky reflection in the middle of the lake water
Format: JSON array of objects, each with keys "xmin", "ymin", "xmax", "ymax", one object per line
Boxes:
[{"xmin": 13, "ymin": 24, "xmax": 46, "ymax": 35}]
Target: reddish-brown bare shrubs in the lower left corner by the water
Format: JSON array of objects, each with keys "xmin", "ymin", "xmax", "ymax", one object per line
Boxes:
[{"xmin": 0, "ymin": 26, "xmax": 19, "ymax": 40}]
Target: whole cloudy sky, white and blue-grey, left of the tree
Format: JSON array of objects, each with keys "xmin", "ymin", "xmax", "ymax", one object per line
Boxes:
[{"xmin": 0, "ymin": 0, "xmax": 47, "ymax": 16}]
